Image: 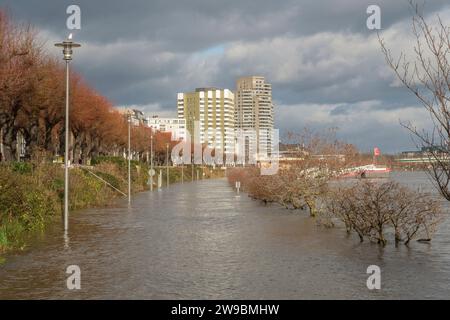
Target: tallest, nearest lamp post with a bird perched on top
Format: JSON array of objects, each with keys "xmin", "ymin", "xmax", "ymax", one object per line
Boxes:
[{"xmin": 55, "ymin": 34, "xmax": 81, "ymax": 231}]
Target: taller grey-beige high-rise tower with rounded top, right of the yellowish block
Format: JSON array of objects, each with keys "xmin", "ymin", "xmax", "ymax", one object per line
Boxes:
[{"xmin": 235, "ymin": 76, "xmax": 274, "ymax": 158}]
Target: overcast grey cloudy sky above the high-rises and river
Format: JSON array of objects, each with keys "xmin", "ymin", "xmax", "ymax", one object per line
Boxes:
[{"xmin": 0, "ymin": 0, "xmax": 450, "ymax": 153}]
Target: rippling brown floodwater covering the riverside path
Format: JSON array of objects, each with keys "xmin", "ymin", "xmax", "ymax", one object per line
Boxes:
[{"xmin": 0, "ymin": 173, "xmax": 450, "ymax": 299}]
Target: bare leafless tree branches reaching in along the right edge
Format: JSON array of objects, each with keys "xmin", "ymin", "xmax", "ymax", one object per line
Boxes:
[{"xmin": 378, "ymin": 1, "xmax": 450, "ymax": 201}]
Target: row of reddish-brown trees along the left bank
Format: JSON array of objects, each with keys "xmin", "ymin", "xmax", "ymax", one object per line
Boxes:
[{"xmin": 0, "ymin": 10, "xmax": 170, "ymax": 163}]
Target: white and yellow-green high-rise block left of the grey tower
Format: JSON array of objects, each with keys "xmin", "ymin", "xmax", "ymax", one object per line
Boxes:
[{"xmin": 177, "ymin": 88, "xmax": 235, "ymax": 154}]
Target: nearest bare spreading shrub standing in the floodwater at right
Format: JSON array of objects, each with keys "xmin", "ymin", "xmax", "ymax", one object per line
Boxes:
[{"xmin": 321, "ymin": 181, "xmax": 442, "ymax": 245}]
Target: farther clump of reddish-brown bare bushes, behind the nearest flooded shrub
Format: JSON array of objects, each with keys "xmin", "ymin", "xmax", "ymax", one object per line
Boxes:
[{"xmin": 228, "ymin": 129, "xmax": 363, "ymax": 216}]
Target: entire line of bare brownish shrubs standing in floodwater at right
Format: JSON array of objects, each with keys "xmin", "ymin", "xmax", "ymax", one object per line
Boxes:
[{"xmin": 228, "ymin": 131, "xmax": 442, "ymax": 245}]
